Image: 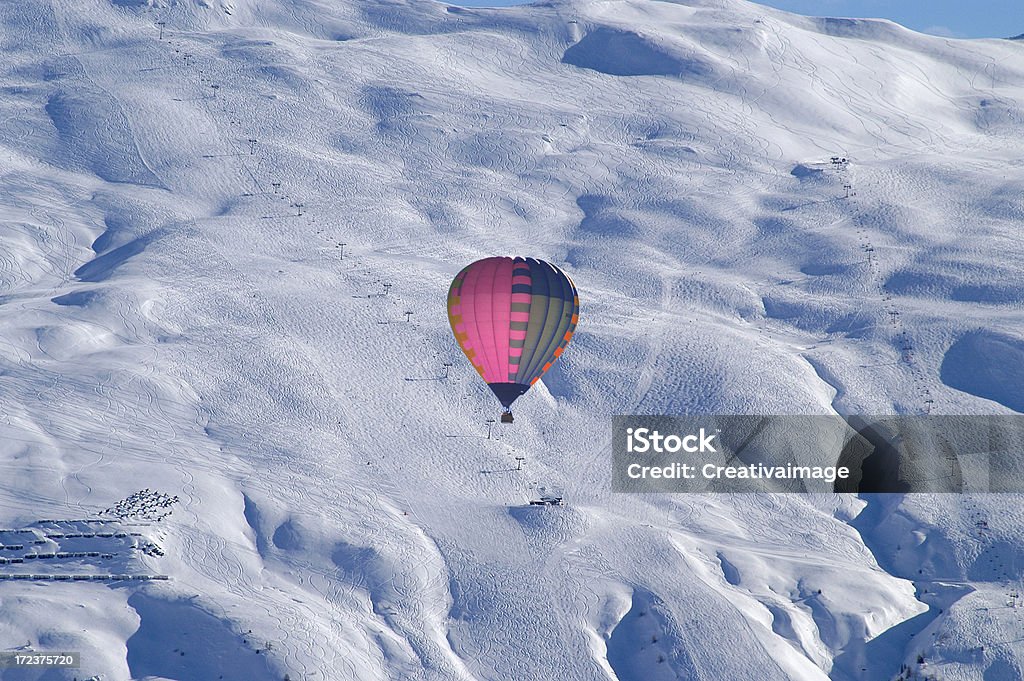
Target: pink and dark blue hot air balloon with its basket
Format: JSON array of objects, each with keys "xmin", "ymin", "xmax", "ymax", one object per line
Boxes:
[{"xmin": 447, "ymin": 257, "xmax": 580, "ymax": 423}]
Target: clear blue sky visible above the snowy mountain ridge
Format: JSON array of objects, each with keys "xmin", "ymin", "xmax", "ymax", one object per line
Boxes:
[{"xmin": 449, "ymin": 0, "xmax": 1024, "ymax": 38}]
